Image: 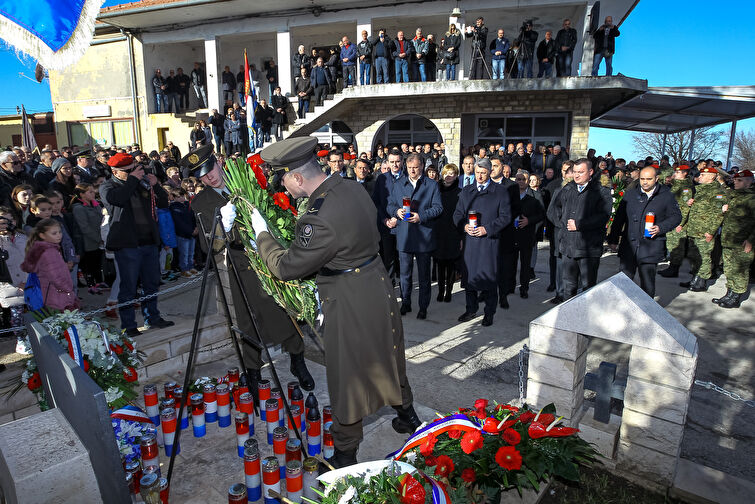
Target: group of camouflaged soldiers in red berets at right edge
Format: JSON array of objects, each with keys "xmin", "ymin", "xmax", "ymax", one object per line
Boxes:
[{"xmin": 659, "ymin": 161, "xmax": 755, "ymax": 308}]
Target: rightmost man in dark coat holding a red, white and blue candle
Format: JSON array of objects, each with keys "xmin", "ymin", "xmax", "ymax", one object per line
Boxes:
[{"xmin": 608, "ymin": 166, "xmax": 682, "ymax": 297}]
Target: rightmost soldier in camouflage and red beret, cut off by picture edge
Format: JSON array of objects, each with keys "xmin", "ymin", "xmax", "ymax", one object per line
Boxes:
[{"xmin": 712, "ymin": 170, "xmax": 755, "ymax": 308}]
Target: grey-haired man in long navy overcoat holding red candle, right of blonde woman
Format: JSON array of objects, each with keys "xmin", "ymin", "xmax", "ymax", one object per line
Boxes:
[{"xmin": 453, "ymin": 158, "xmax": 511, "ymax": 326}]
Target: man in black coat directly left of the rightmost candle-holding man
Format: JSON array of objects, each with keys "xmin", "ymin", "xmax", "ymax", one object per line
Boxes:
[{"xmin": 548, "ymin": 158, "xmax": 612, "ymax": 299}]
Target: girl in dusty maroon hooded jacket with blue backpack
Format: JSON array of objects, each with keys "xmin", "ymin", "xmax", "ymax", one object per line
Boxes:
[{"xmin": 21, "ymin": 219, "xmax": 79, "ymax": 310}]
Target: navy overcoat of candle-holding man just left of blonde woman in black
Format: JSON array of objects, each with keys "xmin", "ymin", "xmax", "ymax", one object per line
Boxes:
[{"xmin": 388, "ymin": 175, "xmax": 443, "ymax": 254}]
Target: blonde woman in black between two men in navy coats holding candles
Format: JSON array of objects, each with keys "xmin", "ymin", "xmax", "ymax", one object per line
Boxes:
[{"xmin": 433, "ymin": 164, "xmax": 461, "ymax": 303}]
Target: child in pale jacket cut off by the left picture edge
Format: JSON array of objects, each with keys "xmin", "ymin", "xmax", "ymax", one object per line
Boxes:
[{"xmin": 0, "ymin": 207, "xmax": 30, "ymax": 355}]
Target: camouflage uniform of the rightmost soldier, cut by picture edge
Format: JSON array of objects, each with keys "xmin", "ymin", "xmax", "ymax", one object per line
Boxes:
[{"xmin": 721, "ymin": 186, "xmax": 755, "ymax": 294}]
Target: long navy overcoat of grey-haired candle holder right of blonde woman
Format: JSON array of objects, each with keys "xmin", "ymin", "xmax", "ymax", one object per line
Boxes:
[{"xmin": 454, "ymin": 182, "xmax": 511, "ymax": 290}]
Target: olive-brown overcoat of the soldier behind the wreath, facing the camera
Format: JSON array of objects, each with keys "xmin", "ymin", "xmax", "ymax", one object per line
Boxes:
[{"xmin": 191, "ymin": 187, "xmax": 300, "ymax": 368}]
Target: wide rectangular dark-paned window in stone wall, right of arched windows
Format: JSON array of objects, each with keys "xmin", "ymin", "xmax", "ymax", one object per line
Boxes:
[{"xmin": 475, "ymin": 114, "xmax": 569, "ymax": 150}]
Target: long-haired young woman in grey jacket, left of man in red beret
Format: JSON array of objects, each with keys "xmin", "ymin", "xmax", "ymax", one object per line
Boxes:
[{"xmin": 71, "ymin": 184, "xmax": 108, "ymax": 294}]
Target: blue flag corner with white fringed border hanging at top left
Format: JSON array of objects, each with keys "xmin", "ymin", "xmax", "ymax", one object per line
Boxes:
[{"xmin": 0, "ymin": 0, "xmax": 103, "ymax": 70}]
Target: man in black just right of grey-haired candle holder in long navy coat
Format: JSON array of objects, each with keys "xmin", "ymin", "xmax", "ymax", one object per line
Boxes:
[{"xmin": 503, "ymin": 172, "xmax": 545, "ymax": 298}]
